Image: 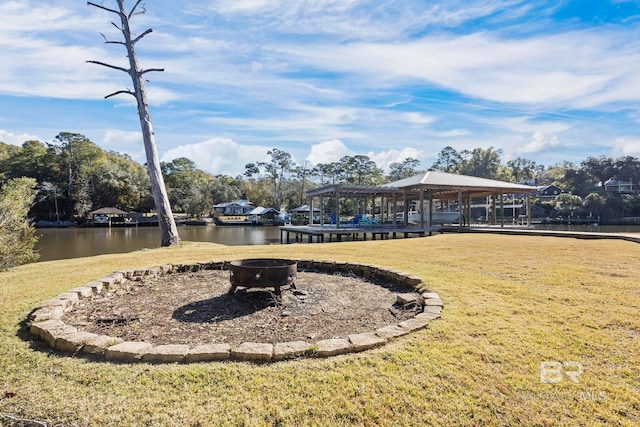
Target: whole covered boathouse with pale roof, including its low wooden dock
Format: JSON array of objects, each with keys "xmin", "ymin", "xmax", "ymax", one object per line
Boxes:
[{"xmin": 280, "ymin": 170, "xmax": 537, "ymax": 243}]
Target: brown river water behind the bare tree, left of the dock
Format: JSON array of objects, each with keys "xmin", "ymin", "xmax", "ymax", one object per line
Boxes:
[{"xmin": 36, "ymin": 226, "xmax": 280, "ymax": 261}]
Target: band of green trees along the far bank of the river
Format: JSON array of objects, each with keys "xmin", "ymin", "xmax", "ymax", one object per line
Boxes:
[{"xmin": 0, "ymin": 132, "xmax": 640, "ymax": 221}]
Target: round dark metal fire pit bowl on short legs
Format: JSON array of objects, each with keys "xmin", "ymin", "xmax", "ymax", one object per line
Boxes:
[{"xmin": 229, "ymin": 258, "xmax": 298, "ymax": 295}]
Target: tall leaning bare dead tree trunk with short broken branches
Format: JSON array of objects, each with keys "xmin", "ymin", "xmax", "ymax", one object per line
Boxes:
[{"xmin": 87, "ymin": 0, "xmax": 180, "ymax": 246}]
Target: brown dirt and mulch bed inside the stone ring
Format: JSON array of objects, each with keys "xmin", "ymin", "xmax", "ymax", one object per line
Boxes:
[{"xmin": 63, "ymin": 270, "xmax": 421, "ymax": 346}]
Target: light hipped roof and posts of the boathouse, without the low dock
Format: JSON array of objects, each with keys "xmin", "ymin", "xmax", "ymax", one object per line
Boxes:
[{"xmin": 307, "ymin": 170, "xmax": 536, "ymax": 228}]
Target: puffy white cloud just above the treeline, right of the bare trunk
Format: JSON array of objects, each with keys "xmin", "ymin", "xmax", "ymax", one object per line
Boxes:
[{"xmin": 160, "ymin": 138, "xmax": 270, "ymax": 176}]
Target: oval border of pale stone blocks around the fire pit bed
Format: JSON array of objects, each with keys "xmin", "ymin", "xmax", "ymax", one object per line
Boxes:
[{"xmin": 29, "ymin": 260, "xmax": 444, "ymax": 363}]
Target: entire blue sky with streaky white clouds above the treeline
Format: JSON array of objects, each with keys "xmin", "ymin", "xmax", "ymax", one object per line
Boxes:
[{"xmin": 0, "ymin": 0, "xmax": 640, "ymax": 176}]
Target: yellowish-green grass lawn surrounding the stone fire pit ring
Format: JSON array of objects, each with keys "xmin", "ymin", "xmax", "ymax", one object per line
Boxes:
[{"xmin": 0, "ymin": 234, "xmax": 640, "ymax": 426}]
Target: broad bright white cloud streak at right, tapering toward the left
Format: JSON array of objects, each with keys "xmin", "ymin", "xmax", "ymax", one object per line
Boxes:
[{"xmin": 282, "ymin": 29, "xmax": 640, "ymax": 108}]
